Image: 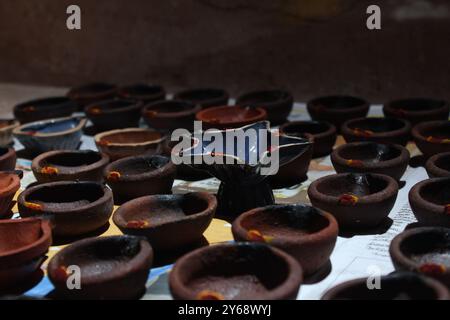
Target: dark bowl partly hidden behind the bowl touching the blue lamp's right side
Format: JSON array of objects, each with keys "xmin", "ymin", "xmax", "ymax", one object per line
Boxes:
[{"xmin": 280, "ymin": 121, "xmax": 337, "ymax": 158}]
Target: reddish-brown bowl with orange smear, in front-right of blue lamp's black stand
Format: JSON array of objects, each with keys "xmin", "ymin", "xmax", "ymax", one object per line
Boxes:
[{"xmin": 232, "ymin": 204, "xmax": 338, "ymax": 276}]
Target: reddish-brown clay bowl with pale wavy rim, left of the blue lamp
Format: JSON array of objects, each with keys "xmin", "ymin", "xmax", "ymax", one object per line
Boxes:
[{"xmin": 94, "ymin": 128, "xmax": 165, "ymax": 161}]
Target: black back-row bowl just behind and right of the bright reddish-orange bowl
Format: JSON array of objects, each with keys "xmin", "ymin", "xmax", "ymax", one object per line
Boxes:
[{"xmin": 236, "ymin": 90, "xmax": 294, "ymax": 125}]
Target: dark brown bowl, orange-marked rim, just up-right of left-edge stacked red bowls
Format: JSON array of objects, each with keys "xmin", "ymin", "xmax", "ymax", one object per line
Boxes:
[{"xmin": 17, "ymin": 181, "xmax": 113, "ymax": 237}]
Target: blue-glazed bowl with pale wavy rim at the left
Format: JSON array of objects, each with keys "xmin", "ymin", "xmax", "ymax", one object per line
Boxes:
[{"xmin": 13, "ymin": 118, "xmax": 86, "ymax": 153}]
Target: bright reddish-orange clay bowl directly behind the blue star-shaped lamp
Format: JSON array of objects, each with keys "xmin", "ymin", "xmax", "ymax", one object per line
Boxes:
[{"xmin": 195, "ymin": 106, "xmax": 267, "ymax": 129}]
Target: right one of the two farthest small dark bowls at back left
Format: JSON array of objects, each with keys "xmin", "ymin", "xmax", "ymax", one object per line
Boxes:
[{"xmin": 117, "ymin": 83, "xmax": 166, "ymax": 103}]
